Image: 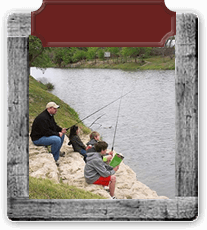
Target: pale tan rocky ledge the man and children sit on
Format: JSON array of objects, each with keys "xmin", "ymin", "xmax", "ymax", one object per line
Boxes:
[{"xmin": 29, "ymin": 136, "xmax": 168, "ymax": 199}]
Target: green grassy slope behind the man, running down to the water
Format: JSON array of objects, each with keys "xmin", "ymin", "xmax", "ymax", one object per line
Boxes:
[{"xmin": 29, "ymin": 76, "xmax": 91, "ymax": 134}]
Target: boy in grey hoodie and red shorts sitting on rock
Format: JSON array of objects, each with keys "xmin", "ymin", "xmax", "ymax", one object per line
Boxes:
[{"xmin": 84, "ymin": 141, "xmax": 119, "ymax": 199}]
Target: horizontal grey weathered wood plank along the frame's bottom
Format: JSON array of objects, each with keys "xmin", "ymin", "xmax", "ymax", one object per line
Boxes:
[{"xmin": 8, "ymin": 197, "xmax": 198, "ymax": 220}]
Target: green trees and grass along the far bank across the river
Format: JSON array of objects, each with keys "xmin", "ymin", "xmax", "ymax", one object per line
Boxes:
[{"xmin": 29, "ymin": 36, "xmax": 175, "ymax": 70}]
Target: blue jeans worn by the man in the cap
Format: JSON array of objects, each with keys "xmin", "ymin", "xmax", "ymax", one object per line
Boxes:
[{"xmin": 33, "ymin": 134, "xmax": 65, "ymax": 161}]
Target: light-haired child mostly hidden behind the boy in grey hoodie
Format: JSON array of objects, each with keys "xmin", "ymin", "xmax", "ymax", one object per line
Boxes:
[{"xmin": 86, "ymin": 131, "xmax": 113, "ymax": 163}]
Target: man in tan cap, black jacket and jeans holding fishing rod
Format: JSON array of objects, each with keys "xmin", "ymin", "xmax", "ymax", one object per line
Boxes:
[{"xmin": 30, "ymin": 102, "xmax": 67, "ymax": 165}]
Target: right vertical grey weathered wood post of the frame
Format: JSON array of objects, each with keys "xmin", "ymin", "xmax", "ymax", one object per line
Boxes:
[{"xmin": 175, "ymin": 13, "xmax": 198, "ymax": 196}]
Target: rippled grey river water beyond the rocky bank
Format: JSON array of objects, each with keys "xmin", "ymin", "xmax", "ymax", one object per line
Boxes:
[{"xmin": 30, "ymin": 67, "xmax": 175, "ymax": 199}]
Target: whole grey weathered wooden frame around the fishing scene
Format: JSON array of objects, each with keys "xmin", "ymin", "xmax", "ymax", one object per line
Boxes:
[{"xmin": 7, "ymin": 13, "xmax": 198, "ymax": 220}]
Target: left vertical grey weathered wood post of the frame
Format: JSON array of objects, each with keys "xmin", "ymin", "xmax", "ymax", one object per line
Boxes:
[{"xmin": 7, "ymin": 14, "xmax": 29, "ymax": 198}]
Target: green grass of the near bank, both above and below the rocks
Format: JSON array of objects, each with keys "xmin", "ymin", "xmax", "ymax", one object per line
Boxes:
[{"xmin": 29, "ymin": 76, "xmax": 104, "ymax": 199}]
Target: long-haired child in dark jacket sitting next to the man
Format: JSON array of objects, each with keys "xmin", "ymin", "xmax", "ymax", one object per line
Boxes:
[{"xmin": 68, "ymin": 125, "xmax": 87, "ymax": 162}]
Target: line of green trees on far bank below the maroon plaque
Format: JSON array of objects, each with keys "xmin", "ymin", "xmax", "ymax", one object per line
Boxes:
[{"xmin": 29, "ymin": 35, "xmax": 174, "ymax": 68}]
